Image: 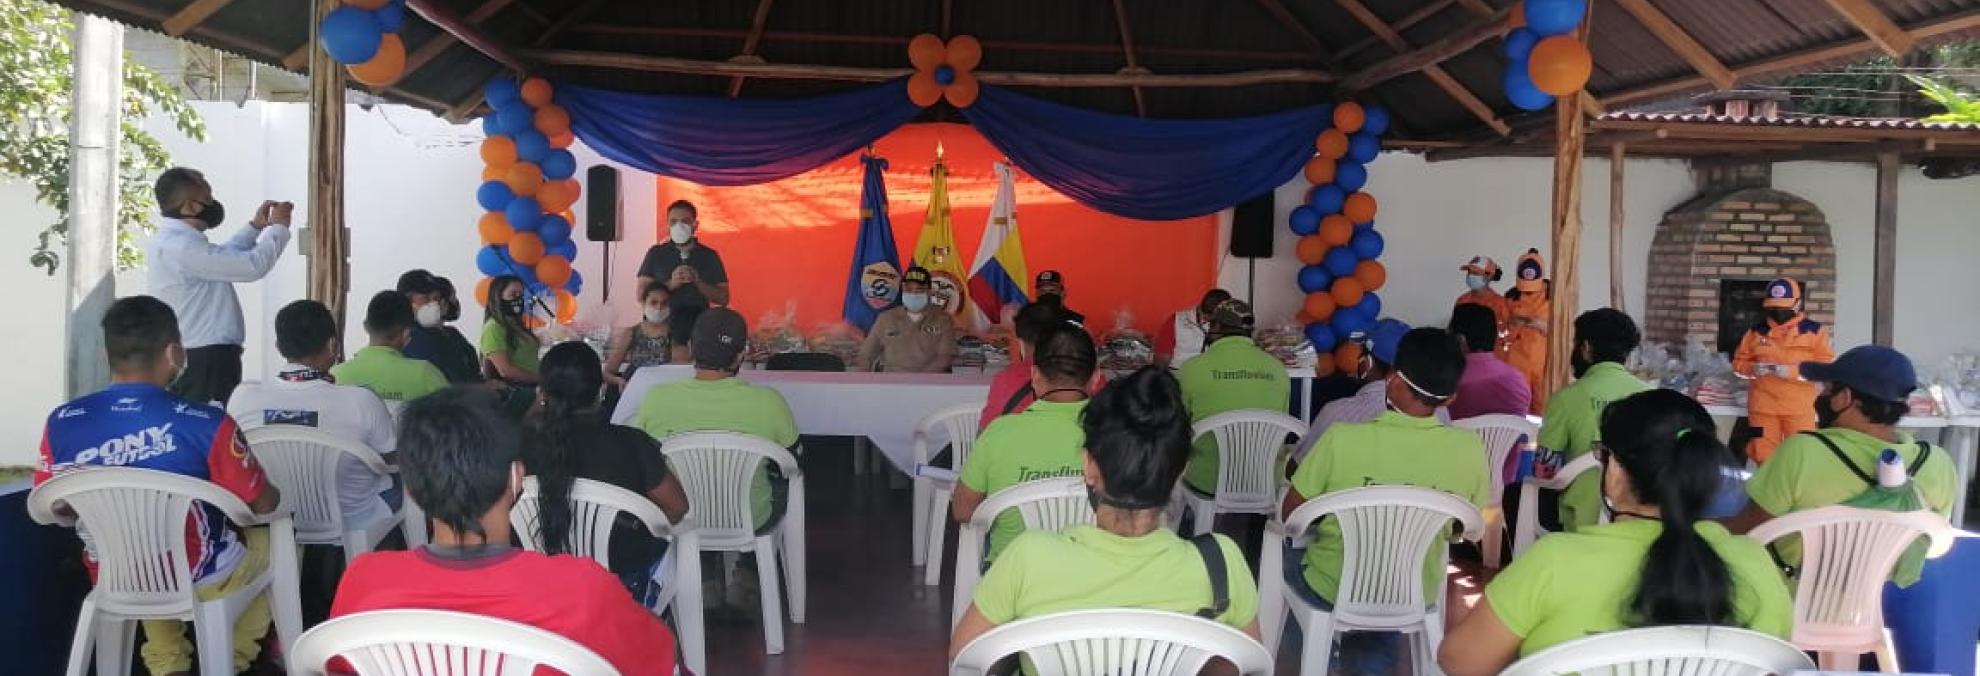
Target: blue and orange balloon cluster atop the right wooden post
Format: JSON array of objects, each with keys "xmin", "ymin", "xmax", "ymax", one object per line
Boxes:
[{"xmin": 1505, "ymin": 0, "xmax": 1594, "ymax": 111}]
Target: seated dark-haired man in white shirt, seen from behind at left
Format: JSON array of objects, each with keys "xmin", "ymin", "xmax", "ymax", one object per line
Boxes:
[{"xmin": 228, "ymin": 301, "xmax": 402, "ymax": 525}]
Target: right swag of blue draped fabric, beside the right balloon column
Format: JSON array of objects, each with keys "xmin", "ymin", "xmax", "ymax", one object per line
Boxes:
[{"xmin": 962, "ymin": 85, "xmax": 1333, "ymax": 220}]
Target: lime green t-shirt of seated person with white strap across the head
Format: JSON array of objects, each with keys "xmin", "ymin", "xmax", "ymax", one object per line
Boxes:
[{"xmin": 1283, "ymin": 408, "xmax": 1491, "ymax": 601}]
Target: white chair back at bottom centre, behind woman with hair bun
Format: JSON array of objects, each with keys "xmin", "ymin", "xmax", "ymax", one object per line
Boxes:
[{"xmin": 948, "ymin": 609, "xmax": 1271, "ymax": 676}]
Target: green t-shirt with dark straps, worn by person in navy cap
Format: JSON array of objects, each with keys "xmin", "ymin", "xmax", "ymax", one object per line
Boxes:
[{"xmin": 1746, "ymin": 428, "xmax": 1958, "ymax": 565}]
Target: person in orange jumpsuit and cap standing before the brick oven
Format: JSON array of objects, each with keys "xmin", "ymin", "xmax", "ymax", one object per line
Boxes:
[{"xmin": 1733, "ymin": 278, "xmax": 1835, "ymax": 464}]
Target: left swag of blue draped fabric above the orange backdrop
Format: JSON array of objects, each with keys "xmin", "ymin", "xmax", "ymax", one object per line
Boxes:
[{"xmin": 556, "ymin": 77, "xmax": 922, "ymax": 186}]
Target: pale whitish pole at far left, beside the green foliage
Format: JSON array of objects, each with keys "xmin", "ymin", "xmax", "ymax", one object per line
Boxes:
[{"xmin": 63, "ymin": 14, "xmax": 123, "ymax": 398}]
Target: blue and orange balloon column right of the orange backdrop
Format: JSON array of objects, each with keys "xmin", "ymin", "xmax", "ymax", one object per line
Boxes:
[{"xmin": 1289, "ymin": 101, "xmax": 1388, "ymax": 375}]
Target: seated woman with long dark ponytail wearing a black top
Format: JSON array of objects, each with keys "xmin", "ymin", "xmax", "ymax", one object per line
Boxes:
[{"xmin": 523, "ymin": 343, "xmax": 687, "ymax": 595}]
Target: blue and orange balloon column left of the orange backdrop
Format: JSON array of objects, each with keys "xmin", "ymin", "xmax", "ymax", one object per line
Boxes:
[{"xmin": 475, "ymin": 77, "xmax": 584, "ymax": 323}]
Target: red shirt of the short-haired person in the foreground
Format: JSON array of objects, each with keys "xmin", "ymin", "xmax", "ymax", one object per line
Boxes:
[{"xmin": 331, "ymin": 549, "xmax": 673, "ymax": 676}]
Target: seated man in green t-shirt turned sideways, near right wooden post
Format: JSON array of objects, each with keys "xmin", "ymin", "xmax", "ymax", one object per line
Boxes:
[{"xmin": 1540, "ymin": 307, "xmax": 1649, "ymax": 529}]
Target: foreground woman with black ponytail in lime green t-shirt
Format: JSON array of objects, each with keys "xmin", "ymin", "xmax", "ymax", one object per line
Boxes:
[{"xmin": 1437, "ymin": 391, "xmax": 1794, "ymax": 676}]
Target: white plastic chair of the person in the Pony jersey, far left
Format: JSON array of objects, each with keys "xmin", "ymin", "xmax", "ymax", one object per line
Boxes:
[{"xmin": 28, "ymin": 468, "xmax": 303, "ymax": 676}]
